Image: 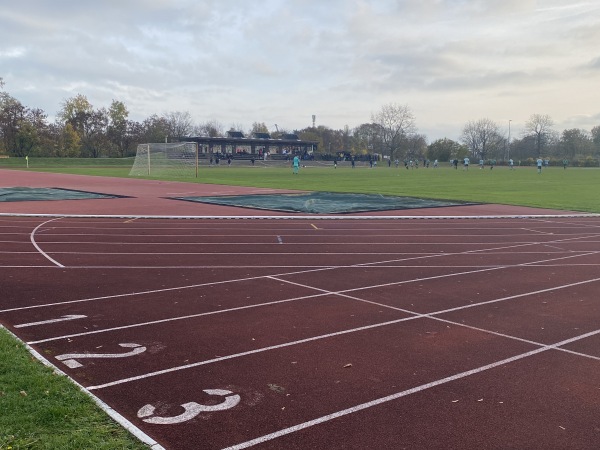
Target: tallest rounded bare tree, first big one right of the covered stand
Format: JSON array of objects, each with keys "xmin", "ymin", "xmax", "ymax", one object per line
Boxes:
[{"xmin": 371, "ymin": 103, "xmax": 416, "ymax": 159}]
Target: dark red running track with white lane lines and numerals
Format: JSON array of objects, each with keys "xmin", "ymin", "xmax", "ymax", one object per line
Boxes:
[{"xmin": 0, "ymin": 172, "xmax": 600, "ymax": 449}]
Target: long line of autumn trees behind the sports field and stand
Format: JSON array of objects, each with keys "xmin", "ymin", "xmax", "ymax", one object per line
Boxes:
[{"xmin": 0, "ymin": 78, "xmax": 600, "ymax": 166}]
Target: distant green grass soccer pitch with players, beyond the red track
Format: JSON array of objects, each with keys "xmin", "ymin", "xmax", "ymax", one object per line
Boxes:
[{"xmin": 0, "ymin": 158, "xmax": 600, "ymax": 213}]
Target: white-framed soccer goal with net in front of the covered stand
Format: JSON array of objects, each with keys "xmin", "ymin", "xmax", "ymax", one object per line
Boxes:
[{"xmin": 129, "ymin": 142, "xmax": 198, "ymax": 178}]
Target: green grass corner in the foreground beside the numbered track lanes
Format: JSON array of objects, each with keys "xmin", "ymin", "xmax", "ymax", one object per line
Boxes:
[{"xmin": 0, "ymin": 327, "xmax": 148, "ymax": 450}]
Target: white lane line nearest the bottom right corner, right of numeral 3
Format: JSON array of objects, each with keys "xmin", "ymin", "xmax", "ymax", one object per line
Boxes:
[{"xmin": 223, "ymin": 330, "xmax": 600, "ymax": 450}]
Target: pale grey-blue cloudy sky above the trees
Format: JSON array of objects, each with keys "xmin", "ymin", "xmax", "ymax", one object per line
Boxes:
[{"xmin": 0, "ymin": 0, "xmax": 600, "ymax": 141}]
